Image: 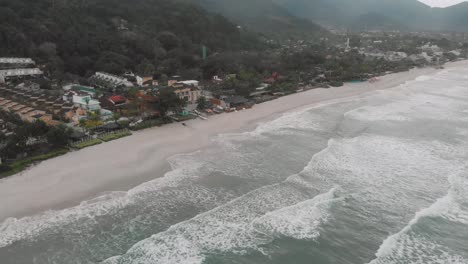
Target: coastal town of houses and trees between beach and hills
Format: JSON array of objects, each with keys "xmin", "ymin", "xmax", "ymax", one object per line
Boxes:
[{"xmin": 0, "ymin": 32, "xmax": 468, "ymax": 177}]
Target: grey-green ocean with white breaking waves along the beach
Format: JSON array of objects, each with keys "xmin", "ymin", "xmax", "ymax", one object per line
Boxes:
[{"xmin": 0, "ymin": 65, "xmax": 468, "ymax": 264}]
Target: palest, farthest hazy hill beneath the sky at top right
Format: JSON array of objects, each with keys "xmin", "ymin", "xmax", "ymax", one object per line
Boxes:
[{"xmin": 274, "ymin": 0, "xmax": 468, "ymax": 31}]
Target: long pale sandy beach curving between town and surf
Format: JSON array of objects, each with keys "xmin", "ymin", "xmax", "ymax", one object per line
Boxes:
[{"xmin": 0, "ymin": 65, "xmax": 450, "ymax": 221}]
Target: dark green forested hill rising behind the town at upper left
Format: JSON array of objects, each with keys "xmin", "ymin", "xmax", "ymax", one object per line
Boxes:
[{"xmin": 0, "ymin": 0, "xmax": 261, "ymax": 77}]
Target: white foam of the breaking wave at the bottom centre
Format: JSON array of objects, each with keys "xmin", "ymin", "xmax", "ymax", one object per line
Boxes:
[{"xmin": 104, "ymin": 184, "xmax": 340, "ymax": 264}]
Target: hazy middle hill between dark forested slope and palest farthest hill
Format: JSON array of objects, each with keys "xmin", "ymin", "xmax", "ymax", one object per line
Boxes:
[{"xmin": 182, "ymin": 0, "xmax": 323, "ymax": 34}]
